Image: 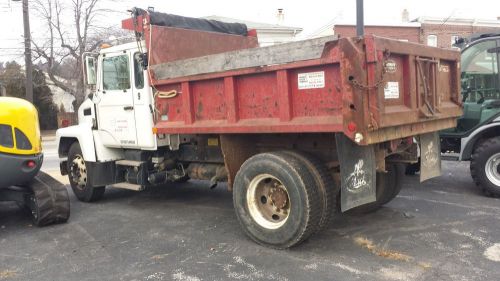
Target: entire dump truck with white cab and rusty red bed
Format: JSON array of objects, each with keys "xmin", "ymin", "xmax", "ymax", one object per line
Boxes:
[{"xmin": 57, "ymin": 9, "xmax": 462, "ymax": 248}]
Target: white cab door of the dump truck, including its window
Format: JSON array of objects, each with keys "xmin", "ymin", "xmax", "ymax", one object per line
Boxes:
[{"xmin": 96, "ymin": 51, "xmax": 137, "ymax": 148}]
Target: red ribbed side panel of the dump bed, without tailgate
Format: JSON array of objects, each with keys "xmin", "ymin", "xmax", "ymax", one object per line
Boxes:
[{"xmin": 156, "ymin": 63, "xmax": 342, "ymax": 133}]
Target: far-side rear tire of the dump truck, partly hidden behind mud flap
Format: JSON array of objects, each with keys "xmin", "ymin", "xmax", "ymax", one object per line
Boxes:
[{"xmin": 347, "ymin": 163, "xmax": 403, "ymax": 214}]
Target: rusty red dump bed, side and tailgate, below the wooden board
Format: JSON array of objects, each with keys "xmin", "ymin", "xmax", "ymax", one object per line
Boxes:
[{"xmin": 153, "ymin": 33, "xmax": 462, "ymax": 145}]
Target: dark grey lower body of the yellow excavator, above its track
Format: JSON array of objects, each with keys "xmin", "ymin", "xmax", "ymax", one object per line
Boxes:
[{"xmin": 0, "ymin": 153, "xmax": 43, "ymax": 189}]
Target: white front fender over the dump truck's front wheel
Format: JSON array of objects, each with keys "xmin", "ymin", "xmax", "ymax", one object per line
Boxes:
[{"xmin": 56, "ymin": 123, "xmax": 97, "ymax": 162}]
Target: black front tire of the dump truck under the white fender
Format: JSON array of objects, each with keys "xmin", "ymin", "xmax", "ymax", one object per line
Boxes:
[{"xmin": 68, "ymin": 142, "xmax": 105, "ymax": 202}]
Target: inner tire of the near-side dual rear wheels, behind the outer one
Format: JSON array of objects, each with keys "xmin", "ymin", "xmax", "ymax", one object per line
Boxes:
[{"xmin": 283, "ymin": 150, "xmax": 340, "ymax": 232}]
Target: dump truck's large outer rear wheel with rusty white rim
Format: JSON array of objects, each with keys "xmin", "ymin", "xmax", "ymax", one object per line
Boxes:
[{"xmin": 233, "ymin": 153, "xmax": 322, "ymax": 249}]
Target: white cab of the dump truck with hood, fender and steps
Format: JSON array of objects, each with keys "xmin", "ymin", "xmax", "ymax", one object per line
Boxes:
[{"xmin": 56, "ymin": 42, "xmax": 177, "ymax": 201}]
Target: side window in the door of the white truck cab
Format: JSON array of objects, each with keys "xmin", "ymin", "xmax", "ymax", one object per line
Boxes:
[{"xmin": 102, "ymin": 55, "xmax": 130, "ymax": 91}]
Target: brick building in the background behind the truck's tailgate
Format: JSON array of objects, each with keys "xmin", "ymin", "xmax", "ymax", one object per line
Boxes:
[{"xmin": 311, "ymin": 17, "xmax": 500, "ymax": 48}]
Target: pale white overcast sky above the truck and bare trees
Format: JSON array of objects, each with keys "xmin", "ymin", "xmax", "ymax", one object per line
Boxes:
[{"xmin": 0, "ymin": 0, "xmax": 500, "ymax": 62}]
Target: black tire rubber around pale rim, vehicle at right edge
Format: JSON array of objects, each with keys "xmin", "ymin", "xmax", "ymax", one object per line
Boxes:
[{"xmin": 470, "ymin": 137, "xmax": 500, "ymax": 197}]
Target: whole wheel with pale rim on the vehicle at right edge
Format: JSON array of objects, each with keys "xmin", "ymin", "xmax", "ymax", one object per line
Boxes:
[{"xmin": 470, "ymin": 137, "xmax": 500, "ymax": 196}]
